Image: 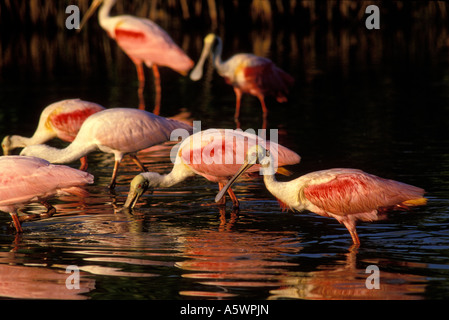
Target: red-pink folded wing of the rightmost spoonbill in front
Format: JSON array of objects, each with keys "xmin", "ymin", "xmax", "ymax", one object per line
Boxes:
[{"xmin": 300, "ymin": 169, "xmax": 424, "ymax": 215}]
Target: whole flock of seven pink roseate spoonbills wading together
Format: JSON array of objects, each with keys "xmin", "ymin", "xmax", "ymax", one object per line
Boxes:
[{"xmin": 0, "ymin": 0, "xmax": 426, "ymax": 246}]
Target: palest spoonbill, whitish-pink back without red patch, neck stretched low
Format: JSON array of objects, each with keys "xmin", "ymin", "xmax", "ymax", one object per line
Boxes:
[{"xmin": 21, "ymin": 108, "xmax": 192, "ymax": 189}]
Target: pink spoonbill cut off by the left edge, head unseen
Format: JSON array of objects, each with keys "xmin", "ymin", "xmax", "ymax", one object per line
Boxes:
[{"xmin": 0, "ymin": 156, "xmax": 94, "ymax": 233}]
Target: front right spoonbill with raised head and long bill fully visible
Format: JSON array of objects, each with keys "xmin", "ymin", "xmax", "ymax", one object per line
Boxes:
[{"xmin": 215, "ymin": 146, "xmax": 427, "ymax": 245}]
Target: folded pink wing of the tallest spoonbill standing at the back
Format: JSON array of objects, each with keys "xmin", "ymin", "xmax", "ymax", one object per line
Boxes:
[{"xmin": 113, "ymin": 15, "xmax": 194, "ymax": 73}]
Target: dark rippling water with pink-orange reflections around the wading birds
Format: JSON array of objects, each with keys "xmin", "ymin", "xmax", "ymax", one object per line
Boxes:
[{"xmin": 0, "ymin": 3, "xmax": 449, "ymax": 299}]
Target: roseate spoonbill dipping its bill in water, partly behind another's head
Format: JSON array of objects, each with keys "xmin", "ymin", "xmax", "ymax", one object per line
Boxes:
[{"xmin": 124, "ymin": 129, "xmax": 301, "ymax": 208}]
